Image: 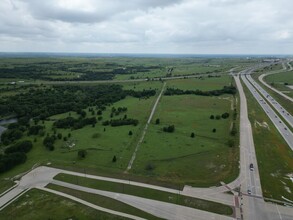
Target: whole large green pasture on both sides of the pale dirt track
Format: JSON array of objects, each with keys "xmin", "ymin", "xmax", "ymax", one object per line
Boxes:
[{"xmin": 1, "ymin": 73, "xmax": 239, "ymax": 188}]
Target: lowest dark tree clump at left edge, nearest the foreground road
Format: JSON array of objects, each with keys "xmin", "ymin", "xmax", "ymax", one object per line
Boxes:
[{"xmin": 0, "ymin": 141, "xmax": 33, "ymax": 173}]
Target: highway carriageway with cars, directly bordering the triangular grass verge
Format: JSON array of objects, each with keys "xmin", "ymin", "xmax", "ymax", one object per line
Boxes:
[{"xmin": 241, "ymin": 70, "xmax": 293, "ymax": 150}]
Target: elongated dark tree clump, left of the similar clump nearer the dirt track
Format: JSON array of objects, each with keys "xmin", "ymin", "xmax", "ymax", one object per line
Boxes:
[{"xmin": 53, "ymin": 117, "xmax": 97, "ymax": 129}]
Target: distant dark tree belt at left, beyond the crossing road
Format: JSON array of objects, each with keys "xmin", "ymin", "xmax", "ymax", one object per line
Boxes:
[{"xmin": 0, "ymin": 61, "xmax": 161, "ymax": 81}]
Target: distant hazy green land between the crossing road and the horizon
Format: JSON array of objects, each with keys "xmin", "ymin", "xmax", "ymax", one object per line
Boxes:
[{"xmin": 0, "ymin": 57, "xmax": 256, "ymax": 82}]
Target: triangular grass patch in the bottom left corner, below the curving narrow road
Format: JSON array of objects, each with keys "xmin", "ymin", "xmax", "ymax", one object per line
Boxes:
[{"xmin": 0, "ymin": 189, "xmax": 127, "ymax": 220}]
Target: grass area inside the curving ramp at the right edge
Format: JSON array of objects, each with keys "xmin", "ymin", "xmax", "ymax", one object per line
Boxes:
[{"xmin": 264, "ymin": 71, "xmax": 293, "ymax": 97}]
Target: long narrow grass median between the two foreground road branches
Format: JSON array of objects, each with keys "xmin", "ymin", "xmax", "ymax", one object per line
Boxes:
[{"xmin": 54, "ymin": 173, "xmax": 233, "ymax": 215}]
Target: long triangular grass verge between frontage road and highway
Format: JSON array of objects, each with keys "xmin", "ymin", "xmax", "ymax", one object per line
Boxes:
[{"xmin": 244, "ymin": 78, "xmax": 293, "ymax": 200}]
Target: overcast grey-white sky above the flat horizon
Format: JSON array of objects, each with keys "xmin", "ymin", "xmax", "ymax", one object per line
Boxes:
[{"xmin": 0, "ymin": 0, "xmax": 293, "ymax": 54}]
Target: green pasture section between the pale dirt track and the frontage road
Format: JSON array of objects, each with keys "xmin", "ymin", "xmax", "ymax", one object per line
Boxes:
[{"xmin": 131, "ymin": 95, "xmax": 239, "ymax": 187}]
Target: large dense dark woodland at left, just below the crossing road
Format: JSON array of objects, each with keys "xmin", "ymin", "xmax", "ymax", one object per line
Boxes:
[{"xmin": 0, "ymin": 85, "xmax": 155, "ymax": 124}]
